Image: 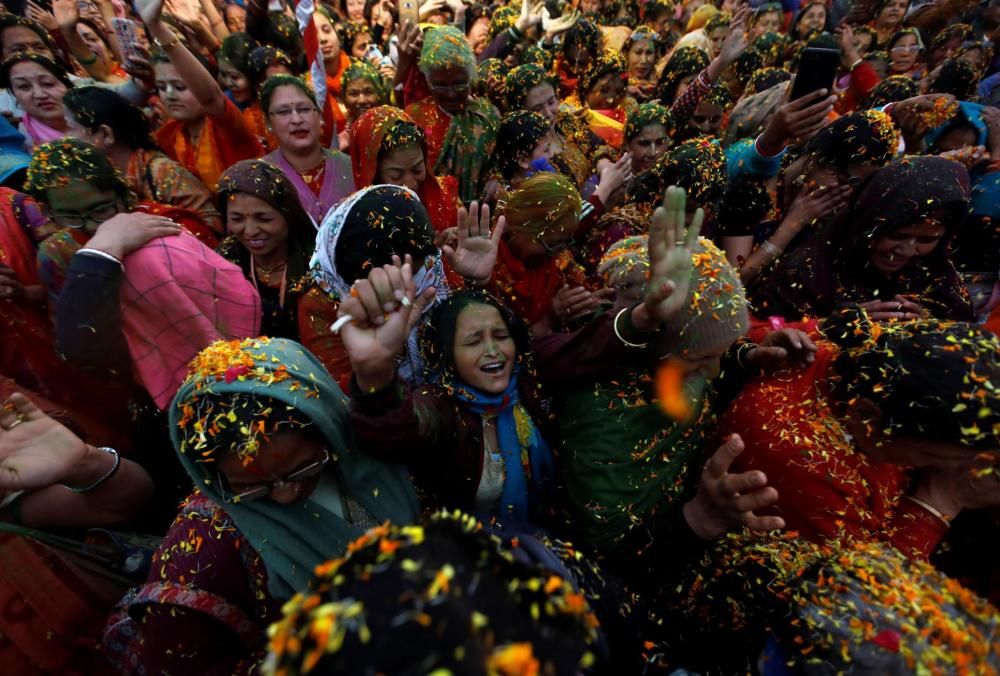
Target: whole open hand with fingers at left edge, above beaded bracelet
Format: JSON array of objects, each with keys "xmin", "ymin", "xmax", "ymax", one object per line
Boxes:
[{"xmin": 0, "ymin": 394, "xmax": 88, "ymax": 491}]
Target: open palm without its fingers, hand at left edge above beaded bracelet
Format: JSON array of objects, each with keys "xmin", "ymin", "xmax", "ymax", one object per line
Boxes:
[{"xmin": 0, "ymin": 416, "xmax": 87, "ymax": 491}]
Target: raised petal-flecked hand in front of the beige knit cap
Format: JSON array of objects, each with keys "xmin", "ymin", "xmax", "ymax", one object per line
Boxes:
[{"xmin": 633, "ymin": 186, "xmax": 705, "ymax": 328}]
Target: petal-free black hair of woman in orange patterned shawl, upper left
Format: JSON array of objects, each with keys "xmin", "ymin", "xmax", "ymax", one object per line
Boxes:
[{"xmin": 63, "ymin": 85, "xmax": 159, "ymax": 150}]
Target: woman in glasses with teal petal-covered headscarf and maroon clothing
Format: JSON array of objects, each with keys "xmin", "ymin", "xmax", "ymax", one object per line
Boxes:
[{"xmin": 105, "ymin": 338, "xmax": 418, "ymax": 674}]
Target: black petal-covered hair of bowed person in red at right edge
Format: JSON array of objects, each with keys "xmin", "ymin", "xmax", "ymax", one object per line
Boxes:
[{"xmin": 822, "ymin": 306, "xmax": 1000, "ymax": 449}]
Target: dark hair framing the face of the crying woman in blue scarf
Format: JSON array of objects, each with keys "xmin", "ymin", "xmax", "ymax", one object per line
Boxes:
[{"xmin": 421, "ymin": 289, "xmax": 531, "ymax": 387}]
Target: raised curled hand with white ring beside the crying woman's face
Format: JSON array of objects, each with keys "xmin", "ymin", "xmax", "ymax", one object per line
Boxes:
[{"xmin": 337, "ymin": 256, "xmax": 434, "ymax": 391}]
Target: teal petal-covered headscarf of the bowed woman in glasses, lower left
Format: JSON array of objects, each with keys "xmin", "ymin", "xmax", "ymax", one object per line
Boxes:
[{"xmin": 169, "ymin": 338, "xmax": 419, "ymax": 600}]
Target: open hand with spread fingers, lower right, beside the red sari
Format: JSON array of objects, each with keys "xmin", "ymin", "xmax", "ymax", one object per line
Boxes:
[{"xmin": 683, "ymin": 434, "xmax": 785, "ymax": 540}]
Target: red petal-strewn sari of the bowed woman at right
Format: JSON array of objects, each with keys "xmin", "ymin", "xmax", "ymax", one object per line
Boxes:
[{"xmin": 720, "ymin": 342, "xmax": 947, "ymax": 559}]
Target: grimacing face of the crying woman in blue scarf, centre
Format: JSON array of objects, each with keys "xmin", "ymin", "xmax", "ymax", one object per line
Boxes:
[{"xmin": 454, "ymin": 304, "xmax": 517, "ymax": 394}]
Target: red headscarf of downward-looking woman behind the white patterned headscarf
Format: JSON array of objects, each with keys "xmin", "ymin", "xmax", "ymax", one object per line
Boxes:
[{"xmin": 351, "ymin": 106, "xmax": 458, "ymax": 232}]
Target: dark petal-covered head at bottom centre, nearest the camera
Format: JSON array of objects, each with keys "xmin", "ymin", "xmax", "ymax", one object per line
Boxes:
[{"xmin": 263, "ymin": 512, "xmax": 601, "ymax": 675}]
